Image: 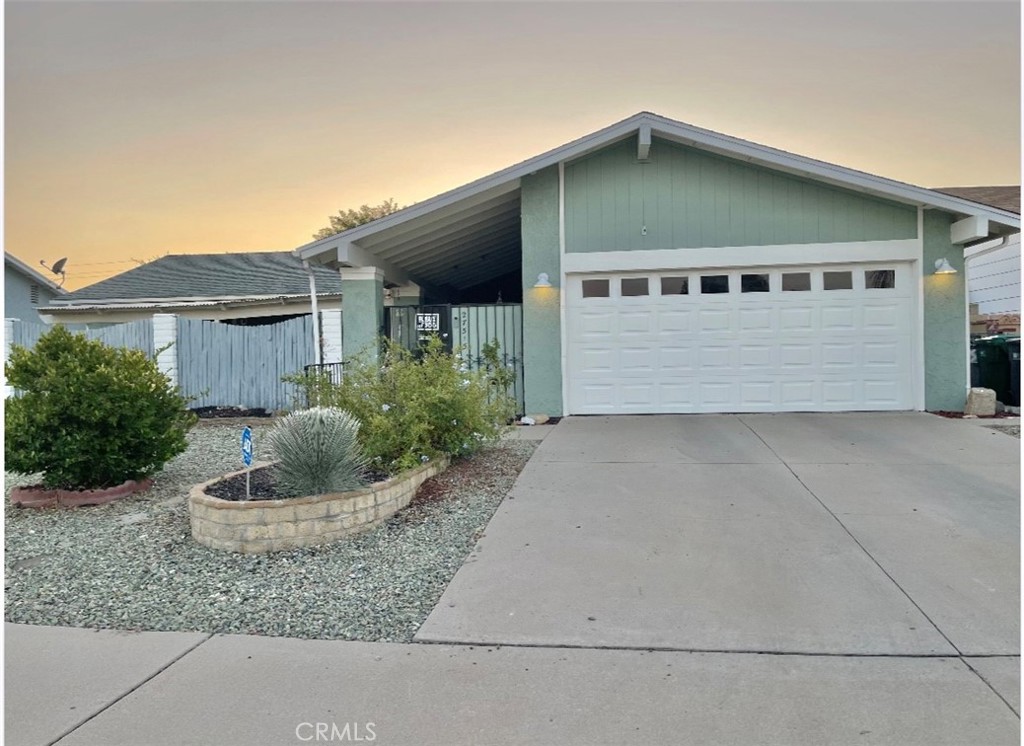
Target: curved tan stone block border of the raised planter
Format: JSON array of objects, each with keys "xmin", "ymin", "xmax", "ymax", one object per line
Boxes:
[{"xmin": 188, "ymin": 458, "xmax": 449, "ymax": 554}]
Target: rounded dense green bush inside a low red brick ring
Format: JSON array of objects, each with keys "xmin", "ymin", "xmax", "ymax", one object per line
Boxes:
[{"xmin": 4, "ymin": 326, "xmax": 196, "ymax": 489}]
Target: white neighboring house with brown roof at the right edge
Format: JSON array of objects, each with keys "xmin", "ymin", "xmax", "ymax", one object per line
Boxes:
[{"xmin": 938, "ymin": 186, "xmax": 1021, "ymax": 316}]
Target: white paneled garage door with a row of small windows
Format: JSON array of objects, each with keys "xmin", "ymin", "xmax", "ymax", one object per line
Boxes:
[{"xmin": 566, "ymin": 263, "xmax": 916, "ymax": 414}]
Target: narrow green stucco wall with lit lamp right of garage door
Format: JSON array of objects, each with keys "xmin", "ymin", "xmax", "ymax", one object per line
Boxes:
[{"xmin": 922, "ymin": 210, "xmax": 968, "ymax": 411}]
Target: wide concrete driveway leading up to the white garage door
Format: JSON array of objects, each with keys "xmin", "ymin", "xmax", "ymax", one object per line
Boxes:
[{"xmin": 417, "ymin": 413, "xmax": 1020, "ymax": 659}]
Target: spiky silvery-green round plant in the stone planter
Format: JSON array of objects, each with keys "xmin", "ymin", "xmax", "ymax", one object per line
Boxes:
[{"xmin": 268, "ymin": 406, "xmax": 367, "ymax": 496}]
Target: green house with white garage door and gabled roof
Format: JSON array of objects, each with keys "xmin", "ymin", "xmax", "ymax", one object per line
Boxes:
[{"xmin": 295, "ymin": 113, "xmax": 1020, "ymax": 415}]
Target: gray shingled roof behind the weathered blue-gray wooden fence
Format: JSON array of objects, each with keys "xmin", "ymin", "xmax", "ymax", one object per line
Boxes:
[{"xmin": 54, "ymin": 252, "xmax": 341, "ymax": 305}]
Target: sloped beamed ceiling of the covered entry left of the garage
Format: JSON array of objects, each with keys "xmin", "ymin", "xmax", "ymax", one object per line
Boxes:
[{"xmin": 355, "ymin": 184, "xmax": 522, "ymax": 289}]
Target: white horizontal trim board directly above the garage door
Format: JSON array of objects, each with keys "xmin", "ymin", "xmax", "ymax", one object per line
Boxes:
[{"xmin": 562, "ymin": 238, "xmax": 921, "ymax": 273}]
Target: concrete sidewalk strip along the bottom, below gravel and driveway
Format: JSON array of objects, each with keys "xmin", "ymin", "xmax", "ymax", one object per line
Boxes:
[{"xmin": 5, "ymin": 624, "xmax": 1020, "ymax": 746}]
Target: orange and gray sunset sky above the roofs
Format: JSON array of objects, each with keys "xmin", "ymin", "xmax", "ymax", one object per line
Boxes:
[{"xmin": 4, "ymin": 2, "xmax": 1021, "ymax": 289}]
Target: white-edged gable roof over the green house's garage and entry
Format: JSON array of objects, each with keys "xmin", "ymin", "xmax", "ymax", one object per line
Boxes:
[{"xmin": 295, "ymin": 112, "xmax": 1020, "ymax": 266}]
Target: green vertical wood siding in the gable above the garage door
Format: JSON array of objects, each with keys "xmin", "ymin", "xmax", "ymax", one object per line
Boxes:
[{"xmin": 565, "ymin": 137, "xmax": 918, "ymax": 252}]
